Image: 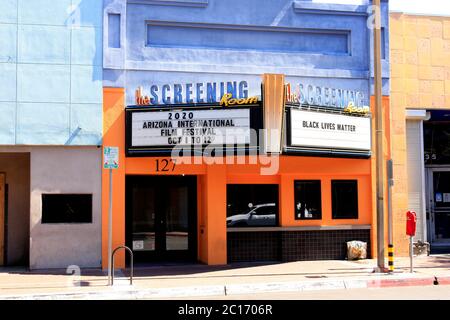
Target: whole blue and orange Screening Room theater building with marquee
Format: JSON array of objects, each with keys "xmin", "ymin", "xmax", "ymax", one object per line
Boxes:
[{"xmin": 102, "ymin": 0, "xmax": 391, "ymax": 267}]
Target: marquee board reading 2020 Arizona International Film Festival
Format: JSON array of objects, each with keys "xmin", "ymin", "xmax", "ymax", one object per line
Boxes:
[{"xmin": 126, "ymin": 104, "xmax": 262, "ymax": 156}]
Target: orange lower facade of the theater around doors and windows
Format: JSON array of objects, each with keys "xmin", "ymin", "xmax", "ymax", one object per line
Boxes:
[{"xmin": 102, "ymin": 75, "xmax": 389, "ymax": 267}]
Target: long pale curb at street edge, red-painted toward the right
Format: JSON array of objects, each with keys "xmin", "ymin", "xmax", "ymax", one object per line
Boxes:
[{"xmin": 0, "ymin": 276, "xmax": 450, "ymax": 300}]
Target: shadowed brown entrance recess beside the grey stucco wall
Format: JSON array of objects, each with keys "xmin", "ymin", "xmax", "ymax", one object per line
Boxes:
[{"xmin": 0, "ymin": 148, "xmax": 30, "ymax": 266}]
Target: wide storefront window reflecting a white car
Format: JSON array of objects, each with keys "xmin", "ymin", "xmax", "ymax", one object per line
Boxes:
[{"xmin": 227, "ymin": 184, "xmax": 278, "ymax": 228}]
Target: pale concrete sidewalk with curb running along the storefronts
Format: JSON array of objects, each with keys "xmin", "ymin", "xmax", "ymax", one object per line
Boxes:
[{"xmin": 0, "ymin": 254, "xmax": 450, "ymax": 299}]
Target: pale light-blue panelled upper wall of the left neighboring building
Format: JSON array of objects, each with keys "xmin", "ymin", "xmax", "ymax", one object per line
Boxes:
[{"xmin": 0, "ymin": 0, "xmax": 103, "ymax": 145}]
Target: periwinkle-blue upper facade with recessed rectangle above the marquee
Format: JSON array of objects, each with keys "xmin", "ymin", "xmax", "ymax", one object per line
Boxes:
[{"xmin": 103, "ymin": 0, "xmax": 389, "ymax": 104}]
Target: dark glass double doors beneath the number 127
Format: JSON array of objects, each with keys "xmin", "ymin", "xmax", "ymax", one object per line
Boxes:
[{"xmin": 126, "ymin": 176, "xmax": 197, "ymax": 262}]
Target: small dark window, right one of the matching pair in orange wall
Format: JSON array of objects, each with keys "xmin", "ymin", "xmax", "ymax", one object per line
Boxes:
[{"xmin": 331, "ymin": 180, "xmax": 358, "ymax": 219}]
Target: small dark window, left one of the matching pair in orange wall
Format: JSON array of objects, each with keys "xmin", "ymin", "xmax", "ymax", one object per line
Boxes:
[{"xmin": 294, "ymin": 180, "xmax": 322, "ymax": 220}]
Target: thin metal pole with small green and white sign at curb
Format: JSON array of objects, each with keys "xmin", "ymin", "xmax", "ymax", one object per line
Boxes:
[{"xmin": 103, "ymin": 147, "xmax": 119, "ymax": 285}]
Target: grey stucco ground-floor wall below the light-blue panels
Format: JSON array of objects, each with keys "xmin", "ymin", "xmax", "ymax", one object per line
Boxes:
[{"xmin": 0, "ymin": 146, "xmax": 102, "ymax": 269}]
